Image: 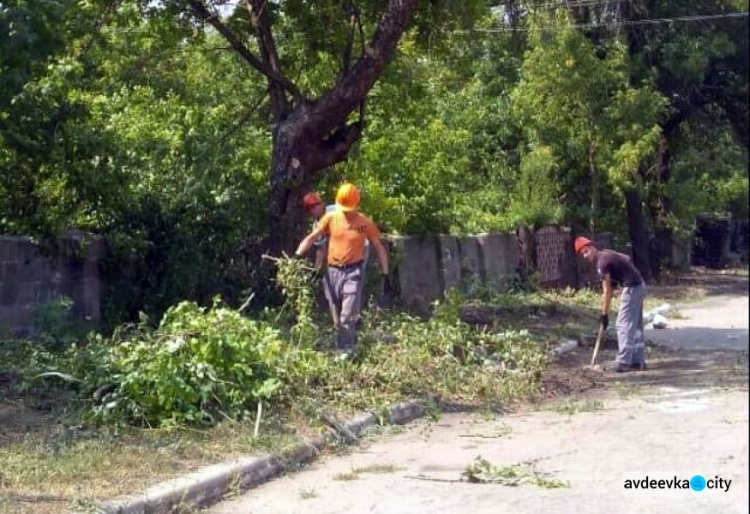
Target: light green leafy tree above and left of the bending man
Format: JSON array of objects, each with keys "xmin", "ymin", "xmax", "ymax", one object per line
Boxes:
[{"xmin": 512, "ymin": 17, "xmax": 667, "ymax": 229}]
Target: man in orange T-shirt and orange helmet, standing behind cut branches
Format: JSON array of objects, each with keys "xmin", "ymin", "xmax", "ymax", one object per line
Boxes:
[{"xmin": 295, "ymin": 183, "xmax": 388, "ymax": 355}]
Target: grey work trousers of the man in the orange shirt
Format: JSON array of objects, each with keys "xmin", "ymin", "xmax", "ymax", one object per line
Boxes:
[{"xmin": 323, "ymin": 263, "xmax": 364, "ymax": 349}]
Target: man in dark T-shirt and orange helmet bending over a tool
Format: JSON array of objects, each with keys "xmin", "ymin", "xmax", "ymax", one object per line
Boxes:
[{"xmin": 573, "ymin": 237, "xmax": 646, "ymax": 373}]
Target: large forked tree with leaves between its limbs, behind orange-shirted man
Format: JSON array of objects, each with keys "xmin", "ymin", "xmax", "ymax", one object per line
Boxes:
[{"xmin": 164, "ymin": 0, "xmax": 481, "ymax": 251}]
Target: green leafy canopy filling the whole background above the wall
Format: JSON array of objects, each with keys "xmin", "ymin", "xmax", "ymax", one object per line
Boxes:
[{"xmin": 0, "ymin": 0, "xmax": 748, "ymax": 326}]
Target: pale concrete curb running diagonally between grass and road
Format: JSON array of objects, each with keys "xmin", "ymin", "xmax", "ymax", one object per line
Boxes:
[{"xmin": 99, "ymin": 399, "xmax": 432, "ymax": 514}]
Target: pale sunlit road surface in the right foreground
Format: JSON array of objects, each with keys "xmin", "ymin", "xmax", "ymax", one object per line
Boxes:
[{"xmin": 209, "ymin": 279, "xmax": 749, "ymax": 514}]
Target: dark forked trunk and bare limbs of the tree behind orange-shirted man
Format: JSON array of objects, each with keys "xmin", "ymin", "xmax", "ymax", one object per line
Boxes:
[{"xmin": 186, "ymin": 0, "xmax": 419, "ymax": 255}]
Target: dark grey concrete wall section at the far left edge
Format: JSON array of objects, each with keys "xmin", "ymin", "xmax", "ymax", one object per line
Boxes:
[{"xmin": 0, "ymin": 231, "xmax": 105, "ymax": 336}]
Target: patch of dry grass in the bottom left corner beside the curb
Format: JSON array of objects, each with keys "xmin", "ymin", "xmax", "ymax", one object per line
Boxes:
[{"xmin": 0, "ymin": 414, "xmax": 306, "ymax": 513}]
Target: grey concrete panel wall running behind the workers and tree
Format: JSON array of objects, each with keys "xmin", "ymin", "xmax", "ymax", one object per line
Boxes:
[{"xmin": 0, "ymin": 227, "xmax": 652, "ymax": 336}]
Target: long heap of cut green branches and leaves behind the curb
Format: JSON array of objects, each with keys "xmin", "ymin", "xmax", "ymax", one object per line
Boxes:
[{"xmin": 0, "ymin": 284, "xmax": 547, "ymax": 427}]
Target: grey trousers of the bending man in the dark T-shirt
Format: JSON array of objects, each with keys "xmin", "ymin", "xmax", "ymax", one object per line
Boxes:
[{"xmin": 616, "ymin": 284, "xmax": 646, "ymax": 366}]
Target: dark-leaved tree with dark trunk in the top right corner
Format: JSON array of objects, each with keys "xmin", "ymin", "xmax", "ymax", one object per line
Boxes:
[{"xmin": 592, "ymin": 0, "xmax": 748, "ymax": 277}]
